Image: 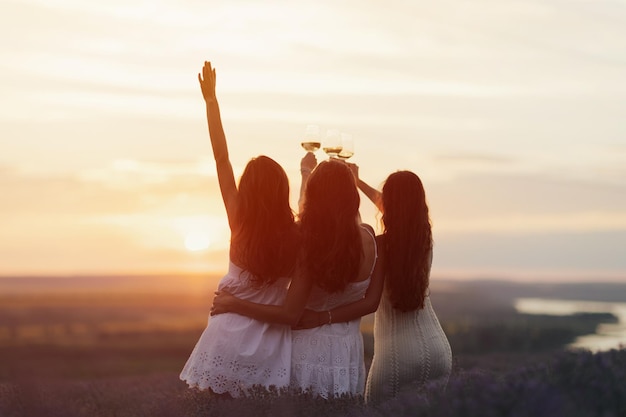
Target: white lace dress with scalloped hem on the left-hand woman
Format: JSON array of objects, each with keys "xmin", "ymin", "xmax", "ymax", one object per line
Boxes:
[{"xmin": 180, "ymin": 262, "xmax": 291, "ymax": 397}]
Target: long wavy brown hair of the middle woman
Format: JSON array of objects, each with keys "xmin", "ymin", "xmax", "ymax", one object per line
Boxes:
[{"xmin": 300, "ymin": 161, "xmax": 363, "ymax": 293}]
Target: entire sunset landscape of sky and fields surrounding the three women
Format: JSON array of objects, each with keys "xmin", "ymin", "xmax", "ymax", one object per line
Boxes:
[{"xmin": 0, "ymin": 0, "xmax": 626, "ymax": 417}]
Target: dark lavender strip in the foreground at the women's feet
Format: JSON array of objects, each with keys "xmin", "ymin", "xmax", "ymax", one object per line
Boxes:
[{"xmin": 0, "ymin": 350, "xmax": 626, "ymax": 417}]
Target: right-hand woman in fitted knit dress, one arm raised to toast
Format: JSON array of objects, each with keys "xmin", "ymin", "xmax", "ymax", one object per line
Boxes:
[{"xmin": 300, "ymin": 164, "xmax": 452, "ymax": 403}]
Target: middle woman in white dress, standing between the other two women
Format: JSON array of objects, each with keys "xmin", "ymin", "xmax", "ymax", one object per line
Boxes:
[{"xmin": 213, "ymin": 158, "xmax": 382, "ymax": 398}]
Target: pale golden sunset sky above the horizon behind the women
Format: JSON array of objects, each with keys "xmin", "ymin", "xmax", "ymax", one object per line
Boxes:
[{"xmin": 0, "ymin": 0, "xmax": 626, "ymax": 282}]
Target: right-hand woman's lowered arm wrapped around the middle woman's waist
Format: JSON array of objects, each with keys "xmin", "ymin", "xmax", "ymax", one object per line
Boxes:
[{"xmin": 294, "ymin": 237, "xmax": 385, "ymax": 329}]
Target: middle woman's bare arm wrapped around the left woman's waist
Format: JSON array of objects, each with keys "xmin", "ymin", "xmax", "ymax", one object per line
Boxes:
[{"xmin": 211, "ymin": 264, "xmax": 312, "ymax": 326}]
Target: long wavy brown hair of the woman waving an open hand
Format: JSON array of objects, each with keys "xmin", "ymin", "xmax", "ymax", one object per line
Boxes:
[{"xmin": 230, "ymin": 156, "xmax": 299, "ymax": 285}]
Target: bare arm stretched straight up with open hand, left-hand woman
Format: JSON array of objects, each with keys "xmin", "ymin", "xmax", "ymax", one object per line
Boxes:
[{"xmin": 198, "ymin": 61, "xmax": 237, "ymax": 229}]
